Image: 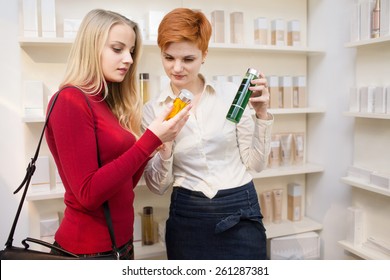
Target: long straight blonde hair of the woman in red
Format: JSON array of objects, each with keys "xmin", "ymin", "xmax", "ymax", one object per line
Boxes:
[{"xmin": 60, "ymin": 9, "xmax": 142, "ymax": 136}]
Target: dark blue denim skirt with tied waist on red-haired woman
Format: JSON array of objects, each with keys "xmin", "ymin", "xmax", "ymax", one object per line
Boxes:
[{"xmin": 165, "ymin": 182, "xmax": 267, "ymax": 260}]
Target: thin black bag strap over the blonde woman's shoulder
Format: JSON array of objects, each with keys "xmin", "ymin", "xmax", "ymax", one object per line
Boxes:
[{"xmin": 5, "ymin": 86, "xmax": 119, "ymax": 259}]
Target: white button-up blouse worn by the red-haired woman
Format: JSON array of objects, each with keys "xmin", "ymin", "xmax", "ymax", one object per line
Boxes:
[{"xmin": 142, "ymin": 77, "xmax": 273, "ymax": 198}]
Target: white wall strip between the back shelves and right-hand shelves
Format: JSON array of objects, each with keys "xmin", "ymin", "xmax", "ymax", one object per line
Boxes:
[{"xmin": 306, "ymin": 0, "xmax": 355, "ymax": 259}]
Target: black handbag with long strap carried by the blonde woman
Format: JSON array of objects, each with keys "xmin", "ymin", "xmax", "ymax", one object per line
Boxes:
[{"xmin": 0, "ymin": 88, "xmax": 120, "ymax": 260}]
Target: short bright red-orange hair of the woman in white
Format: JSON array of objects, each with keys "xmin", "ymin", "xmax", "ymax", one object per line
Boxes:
[{"xmin": 157, "ymin": 8, "xmax": 212, "ymax": 54}]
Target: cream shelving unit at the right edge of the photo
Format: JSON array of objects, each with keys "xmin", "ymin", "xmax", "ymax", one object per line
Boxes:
[{"xmin": 338, "ymin": 14, "xmax": 390, "ymax": 260}]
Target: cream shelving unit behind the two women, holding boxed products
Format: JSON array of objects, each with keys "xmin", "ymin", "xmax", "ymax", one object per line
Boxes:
[{"xmin": 18, "ymin": 0, "xmax": 326, "ymax": 258}]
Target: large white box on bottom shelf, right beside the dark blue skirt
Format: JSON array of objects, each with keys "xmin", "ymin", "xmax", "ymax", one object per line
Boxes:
[{"xmin": 270, "ymin": 232, "xmax": 321, "ymax": 260}]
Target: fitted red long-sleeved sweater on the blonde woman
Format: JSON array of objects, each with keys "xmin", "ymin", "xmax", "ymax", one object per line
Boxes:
[{"xmin": 46, "ymin": 87, "xmax": 162, "ymax": 254}]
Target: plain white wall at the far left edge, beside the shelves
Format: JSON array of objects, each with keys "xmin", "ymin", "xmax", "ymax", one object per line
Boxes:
[{"xmin": 0, "ymin": 0, "xmax": 28, "ymax": 247}]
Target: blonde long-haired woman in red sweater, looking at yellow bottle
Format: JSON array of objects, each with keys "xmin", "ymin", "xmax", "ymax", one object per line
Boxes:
[{"xmin": 46, "ymin": 9, "xmax": 188, "ymax": 259}]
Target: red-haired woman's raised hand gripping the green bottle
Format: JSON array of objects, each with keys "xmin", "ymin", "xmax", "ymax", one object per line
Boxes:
[{"xmin": 249, "ymin": 73, "xmax": 269, "ymax": 120}]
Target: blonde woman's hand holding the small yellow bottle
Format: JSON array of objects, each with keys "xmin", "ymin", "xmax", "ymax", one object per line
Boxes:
[{"xmin": 148, "ymin": 104, "xmax": 192, "ymax": 143}]
